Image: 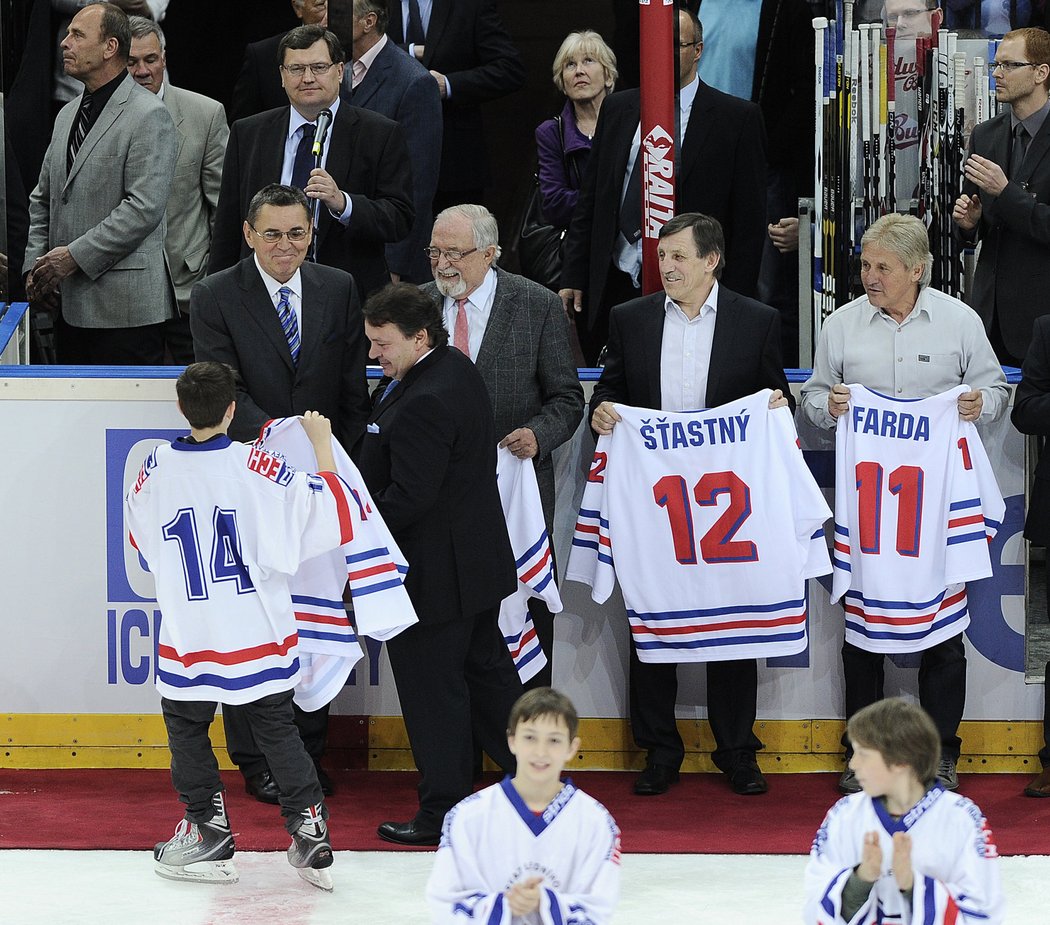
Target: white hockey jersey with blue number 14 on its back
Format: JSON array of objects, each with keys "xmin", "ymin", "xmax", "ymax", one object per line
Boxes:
[{"xmin": 125, "ymin": 436, "xmax": 354, "ymax": 703}]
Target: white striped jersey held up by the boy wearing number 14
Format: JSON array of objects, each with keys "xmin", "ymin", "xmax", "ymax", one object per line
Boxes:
[{"xmin": 255, "ymin": 417, "xmax": 418, "ymax": 711}]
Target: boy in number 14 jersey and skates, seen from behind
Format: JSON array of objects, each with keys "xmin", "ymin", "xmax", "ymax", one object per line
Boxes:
[{"xmin": 125, "ymin": 362, "xmax": 352, "ymax": 890}]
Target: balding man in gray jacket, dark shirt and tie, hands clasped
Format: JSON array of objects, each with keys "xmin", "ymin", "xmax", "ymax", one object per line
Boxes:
[{"xmin": 23, "ymin": 3, "xmax": 176, "ymax": 365}]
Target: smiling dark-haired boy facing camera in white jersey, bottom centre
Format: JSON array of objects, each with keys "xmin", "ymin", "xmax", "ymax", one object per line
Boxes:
[{"xmin": 426, "ymin": 688, "xmax": 620, "ymax": 925}]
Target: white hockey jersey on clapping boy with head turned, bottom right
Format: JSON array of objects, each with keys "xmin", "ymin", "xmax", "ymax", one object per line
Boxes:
[{"xmin": 803, "ymin": 784, "xmax": 1005, "ymax": 925}]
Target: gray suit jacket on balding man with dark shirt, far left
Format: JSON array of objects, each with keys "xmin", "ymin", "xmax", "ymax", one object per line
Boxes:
[{"xmin": 23, "ymin": 75, "xmax": 176, "ymax": 328}]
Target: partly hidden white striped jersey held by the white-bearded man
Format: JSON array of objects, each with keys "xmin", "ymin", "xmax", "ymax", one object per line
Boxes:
[{"xmin": 496, "ymin": 446, "xmax": 562, "ymax": 681}]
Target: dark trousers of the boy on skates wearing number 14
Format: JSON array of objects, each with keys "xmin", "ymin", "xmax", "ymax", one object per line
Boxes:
[{"xmin": 161, "ymin": 691, "xmax": 327, "ymax": 833}]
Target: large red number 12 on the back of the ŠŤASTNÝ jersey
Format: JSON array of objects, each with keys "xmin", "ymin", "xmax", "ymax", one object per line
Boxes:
[{"xmin": 653, "ymin": 472, "xmax": 758, "ymax": 565}]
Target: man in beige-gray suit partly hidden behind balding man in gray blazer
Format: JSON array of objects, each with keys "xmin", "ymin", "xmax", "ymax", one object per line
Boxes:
[{"xmin": 128, "ymin": 16, "xmax": 230, "ymax": 365}]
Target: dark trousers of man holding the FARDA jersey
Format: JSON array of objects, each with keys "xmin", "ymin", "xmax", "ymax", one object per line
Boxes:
[{"xmin": 842, "ymin": 633, "xmax": 966, "ymax": 761}]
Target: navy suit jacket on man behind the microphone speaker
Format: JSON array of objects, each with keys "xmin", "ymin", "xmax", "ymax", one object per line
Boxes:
[{"xmin": 343, "ymin": 41, "xmax": 442, "ymax": 282}]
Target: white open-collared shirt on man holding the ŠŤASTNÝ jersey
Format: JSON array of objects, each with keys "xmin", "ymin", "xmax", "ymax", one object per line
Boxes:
[{"xmin": 659, "ymin": 281, "xmax": 718, "ymax": 412}]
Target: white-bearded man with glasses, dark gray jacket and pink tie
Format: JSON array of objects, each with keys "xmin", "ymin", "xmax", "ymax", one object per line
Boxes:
[{"xmin": 423, "ymin": 205, "xmax": 584, "ymax": 687}]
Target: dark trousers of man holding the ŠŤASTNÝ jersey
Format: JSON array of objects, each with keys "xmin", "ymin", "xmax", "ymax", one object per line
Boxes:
[{"xmin": 629, "ymin": 646, "xmax": 762, "ymax": 774}]
